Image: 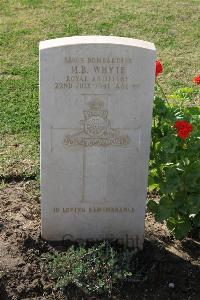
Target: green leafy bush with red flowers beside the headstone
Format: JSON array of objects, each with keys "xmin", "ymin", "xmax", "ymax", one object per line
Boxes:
[{"xmin": 148, "ymin": 64, "xmax": 200, "ymax": 239}]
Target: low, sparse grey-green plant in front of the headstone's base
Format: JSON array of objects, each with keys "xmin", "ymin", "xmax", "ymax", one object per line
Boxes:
[{"xmin": 43, "ymin": 242, "xmax": 135, "ymax": 294}]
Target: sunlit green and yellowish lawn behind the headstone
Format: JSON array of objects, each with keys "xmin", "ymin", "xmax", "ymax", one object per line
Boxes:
[{"xmin": 0, "ymin": 0, "xmax": 200, "ymax": 179}]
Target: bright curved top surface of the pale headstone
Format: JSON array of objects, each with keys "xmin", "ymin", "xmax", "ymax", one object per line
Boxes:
[{"xmin": 40, "ymin": 35, "xmax": 155, "ymax": 50}]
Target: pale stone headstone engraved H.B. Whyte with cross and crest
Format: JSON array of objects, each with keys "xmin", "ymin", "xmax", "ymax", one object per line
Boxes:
[{"xmin": 40, "ymin": 36, "xmax": 156, "ymax": 248}]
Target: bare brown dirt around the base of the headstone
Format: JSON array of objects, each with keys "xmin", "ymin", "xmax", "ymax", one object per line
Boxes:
[{"xmin": 0, "ymin": 181, "xmax": 200, "ymax": 300}]
